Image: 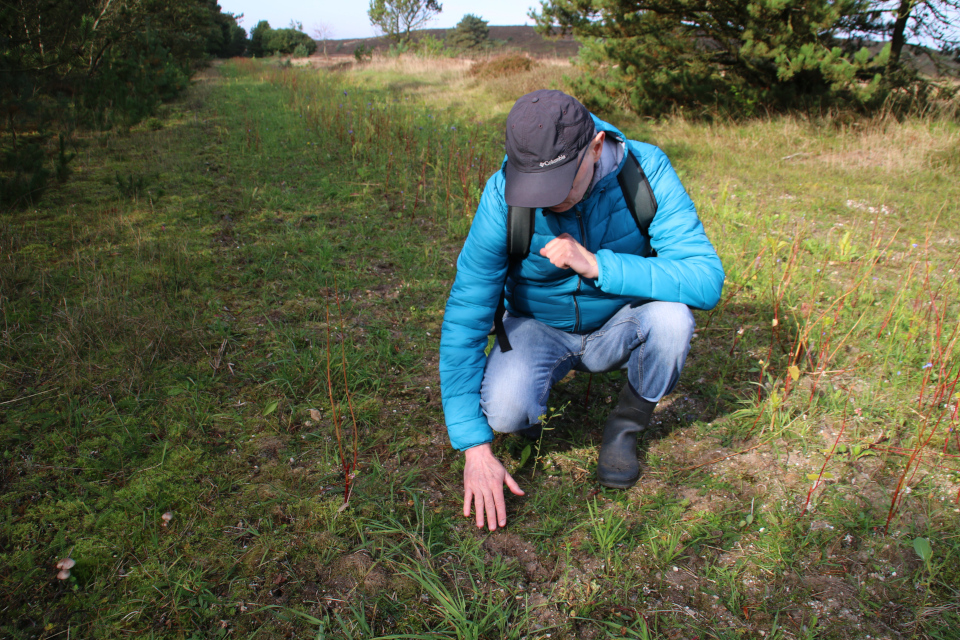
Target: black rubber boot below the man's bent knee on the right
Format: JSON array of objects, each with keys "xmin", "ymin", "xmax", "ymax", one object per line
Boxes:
[{"xmin": 597, "ymin": 383, "xmax": 657, "ymax": 489}]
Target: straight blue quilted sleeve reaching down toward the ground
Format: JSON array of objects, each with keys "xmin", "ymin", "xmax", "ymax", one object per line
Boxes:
[{"xmin": 440, "ymin": 172, "xmax": 508, "ymax": 451}]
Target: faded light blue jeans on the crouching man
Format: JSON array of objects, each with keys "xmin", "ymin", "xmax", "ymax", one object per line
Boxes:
[{"xmin": 480, "ymin": 301, "xmax": 694, "ymax": 433}]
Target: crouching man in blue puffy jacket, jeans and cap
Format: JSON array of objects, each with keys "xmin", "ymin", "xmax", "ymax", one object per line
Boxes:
[{"xmin": 440, "ymin": 90, "xmax": 724, "ymax": 531}]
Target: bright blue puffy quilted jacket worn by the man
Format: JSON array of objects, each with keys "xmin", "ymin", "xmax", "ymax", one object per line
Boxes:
[{"xmin": 440, "ymin": 117, "xmax": 724, "ymax": 451}]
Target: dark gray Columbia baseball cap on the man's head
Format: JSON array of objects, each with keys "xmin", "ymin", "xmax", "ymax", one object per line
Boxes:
[{"xmin": 505, "ymin": 89, "xmax": 594, "ymax": 207}]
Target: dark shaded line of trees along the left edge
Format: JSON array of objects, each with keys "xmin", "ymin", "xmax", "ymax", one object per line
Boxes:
[{"xmin": 0, "ymin": 0, "xmax": 316, "ymax": 210}]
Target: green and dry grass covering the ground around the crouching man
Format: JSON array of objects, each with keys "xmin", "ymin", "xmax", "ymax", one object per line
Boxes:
[{"xmin": 0, "ymin": 56, "xmax": 960, "ymax": 639}]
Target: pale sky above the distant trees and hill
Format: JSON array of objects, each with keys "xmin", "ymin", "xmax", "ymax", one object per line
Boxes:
[{"xmin": 219, "ymin": 0, "xmax": 540, "ymax": 40}]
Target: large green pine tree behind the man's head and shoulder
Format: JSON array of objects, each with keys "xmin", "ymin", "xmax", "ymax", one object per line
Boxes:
[{"xmin": 533, "ymin": 0, "xmax": 889, "ymax": 115}]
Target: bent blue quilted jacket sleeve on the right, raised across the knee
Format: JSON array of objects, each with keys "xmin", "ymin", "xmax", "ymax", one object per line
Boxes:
[{"xmin": 596, "ymin": 141, "xmax": 724, "ymax": 309}]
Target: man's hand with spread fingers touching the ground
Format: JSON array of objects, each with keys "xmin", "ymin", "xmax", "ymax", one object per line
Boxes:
[{"xmin": 463, "ymin": 444, "xmax": 523, "ymax": 531}]
